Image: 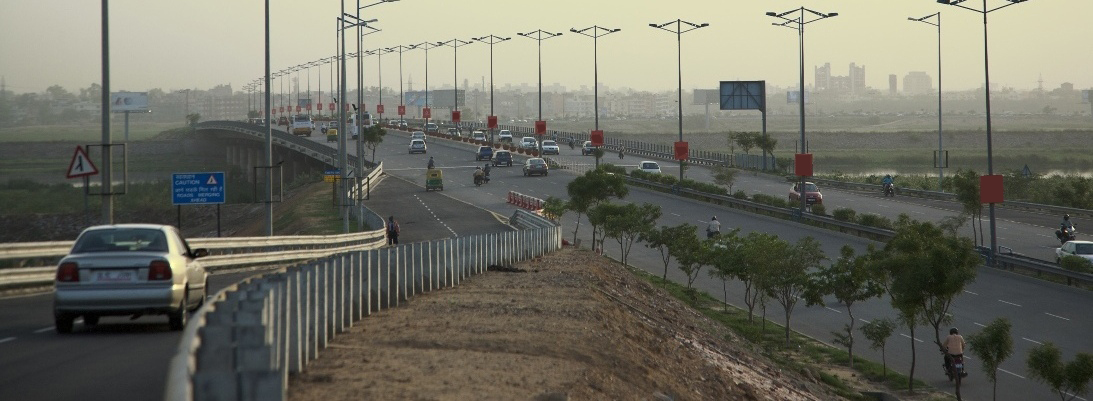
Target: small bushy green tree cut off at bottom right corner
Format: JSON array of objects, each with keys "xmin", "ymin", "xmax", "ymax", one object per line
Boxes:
[{"xmin": 1025, "ymin": 342, "xmax": 1093, "ymax": 401}]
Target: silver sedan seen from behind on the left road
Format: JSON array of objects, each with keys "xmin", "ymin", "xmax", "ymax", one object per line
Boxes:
[{"xmin": 54, "ymin": 224, "xmax": 209, "ymax": 333}]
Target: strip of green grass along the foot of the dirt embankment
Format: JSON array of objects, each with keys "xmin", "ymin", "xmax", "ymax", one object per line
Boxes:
[{"xmin": 630, "ymin": 268, "xmax": 949, "ymax": 400}]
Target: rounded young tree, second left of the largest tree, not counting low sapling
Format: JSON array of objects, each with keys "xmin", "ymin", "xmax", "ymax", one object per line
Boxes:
[{"xmin": 761, "ymin": 237, "xmax": 827, "ymax": 346}]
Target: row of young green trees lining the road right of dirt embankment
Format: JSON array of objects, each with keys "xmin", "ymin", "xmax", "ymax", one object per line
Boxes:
[{"xmin": 544, "ymin": 169, "xmax": 1093, "ymax": 394}]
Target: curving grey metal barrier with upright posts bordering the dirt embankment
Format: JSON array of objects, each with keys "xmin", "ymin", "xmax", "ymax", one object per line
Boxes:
[{"xmin": 164, "ymin": 210, "xmax": 562, "ymax": 401}]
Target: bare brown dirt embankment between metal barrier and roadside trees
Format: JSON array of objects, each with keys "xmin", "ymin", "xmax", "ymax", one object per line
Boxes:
[{"xmin": 289, "ymin": 248, "xmax": 838, "ymax": 401}]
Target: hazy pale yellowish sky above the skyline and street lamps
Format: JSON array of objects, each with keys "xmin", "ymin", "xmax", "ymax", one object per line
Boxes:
[{"xmin": 0, "ymin": 0, "xmax": 1093, "ymax": 93}]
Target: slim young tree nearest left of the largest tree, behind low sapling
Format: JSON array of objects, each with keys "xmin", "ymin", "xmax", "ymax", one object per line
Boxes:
[{"xmin": 804, "ymin": 245, "xmax": 884, "ymax": 368}]
